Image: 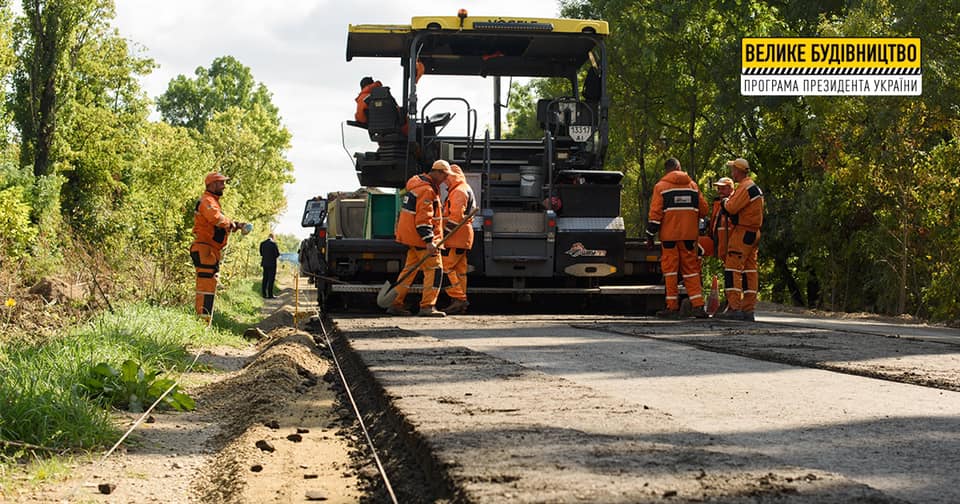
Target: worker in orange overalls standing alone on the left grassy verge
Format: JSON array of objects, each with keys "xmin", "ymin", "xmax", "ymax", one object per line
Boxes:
[{"xmin": 190, "ymin": 172, "xmax": 246, "ymax": 325}]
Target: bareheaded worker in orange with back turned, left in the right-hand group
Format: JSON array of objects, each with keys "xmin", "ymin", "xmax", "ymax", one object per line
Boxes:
[{"xmin": 647, "ymin": 158, "xmax": 708, "ymax": 318}]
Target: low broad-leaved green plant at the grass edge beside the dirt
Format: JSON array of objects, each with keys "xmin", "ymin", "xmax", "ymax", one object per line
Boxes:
[{"xmin": 77, "ymin": 359, "xmax": 196, "ymax": 413}]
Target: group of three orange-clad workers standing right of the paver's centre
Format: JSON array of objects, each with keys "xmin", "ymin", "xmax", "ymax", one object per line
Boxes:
[{"xmin": 646, "ymin": 158, "xmax": 763, "ymax": 321}]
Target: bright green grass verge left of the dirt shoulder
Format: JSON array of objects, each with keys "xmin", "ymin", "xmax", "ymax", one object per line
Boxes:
[{"xmin": 0, "ymin": 282, "xmax": 261, "ymax": 454}]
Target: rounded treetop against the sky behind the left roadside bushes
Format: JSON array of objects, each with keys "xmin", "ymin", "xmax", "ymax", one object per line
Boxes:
[{"xmin": 157, "ymin": 56, "xmax": 280, "ymax": 132}]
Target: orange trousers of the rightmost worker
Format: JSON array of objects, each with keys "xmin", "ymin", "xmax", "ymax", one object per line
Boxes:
[{"xmin": 723, "ymin": 227, "xmax": 760, "ymax": 312}]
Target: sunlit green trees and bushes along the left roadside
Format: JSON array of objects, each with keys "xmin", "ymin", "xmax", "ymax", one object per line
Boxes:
[{"xmin": 0, "ymin": 0, "xmax": 293, "ymax": 302}]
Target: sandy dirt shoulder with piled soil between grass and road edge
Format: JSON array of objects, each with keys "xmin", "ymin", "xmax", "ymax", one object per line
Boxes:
[{"xmin": 29, "ymin": 303, "xmax": 368, "ymax": 503}]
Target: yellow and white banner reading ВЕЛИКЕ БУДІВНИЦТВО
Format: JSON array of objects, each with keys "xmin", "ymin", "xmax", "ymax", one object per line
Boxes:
[{"xmin": 740, "ymin": 38, "xmax": 923, "ymax": 96}]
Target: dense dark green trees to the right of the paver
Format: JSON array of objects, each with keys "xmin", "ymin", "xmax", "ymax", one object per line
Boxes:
[{"xmin": 510, "ymin": 0, "xmax": 960, "ymax": 320}]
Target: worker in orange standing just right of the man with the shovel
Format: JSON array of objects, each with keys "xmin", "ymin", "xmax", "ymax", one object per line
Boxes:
[{"xmin": 440, "ymin": 165, "xmax": 477, "ymax": 315}]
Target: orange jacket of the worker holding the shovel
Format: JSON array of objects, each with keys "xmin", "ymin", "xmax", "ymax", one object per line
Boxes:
[{"xmin": 396, "ymin": 173, "xmax": 443, "ymax": 248}]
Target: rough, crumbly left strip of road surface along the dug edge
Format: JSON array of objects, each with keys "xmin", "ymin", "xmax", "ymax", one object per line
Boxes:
[{"xmin": 337, "ymin": 317, "xmax": 901, "ymax": 503}]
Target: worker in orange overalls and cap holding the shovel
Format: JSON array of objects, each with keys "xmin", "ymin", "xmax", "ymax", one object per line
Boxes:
[{"xmin": 387, "ymin": 159, "xmax": 453, "ymax": 317}]
